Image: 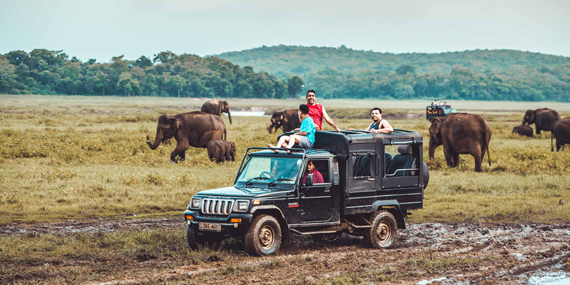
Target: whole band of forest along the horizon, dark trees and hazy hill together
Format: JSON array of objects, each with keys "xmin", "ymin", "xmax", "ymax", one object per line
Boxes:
[{"xmin": 0, "ymin": 45, "xmax": 570, "ymax": 102}]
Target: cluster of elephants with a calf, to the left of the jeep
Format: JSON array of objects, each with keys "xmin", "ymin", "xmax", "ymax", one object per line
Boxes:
[{"xmin": 146, "ymin": 100, "xmax": 236, "ymax": 163}]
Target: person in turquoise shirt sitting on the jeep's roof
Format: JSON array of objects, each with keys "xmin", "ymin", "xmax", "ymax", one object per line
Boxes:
[{"xmin": 267, "ymin": 104, "xmax": 317, "ymax": 153}]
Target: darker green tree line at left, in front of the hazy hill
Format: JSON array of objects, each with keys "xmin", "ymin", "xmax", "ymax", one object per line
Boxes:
[{"xmin": 0, "ymin": 49, "xmax": 303, "ymax": 98}]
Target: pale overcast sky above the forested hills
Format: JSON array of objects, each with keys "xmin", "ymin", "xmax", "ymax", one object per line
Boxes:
[{"xmin": 0, "ymin": 0, "xmax": 570, "ymax": 62}]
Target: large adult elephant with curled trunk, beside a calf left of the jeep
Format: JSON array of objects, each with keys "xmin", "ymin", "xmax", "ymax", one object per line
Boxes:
[{"xmin": 146, "ymin": 111, "xmax": 227, "ymax": 162}]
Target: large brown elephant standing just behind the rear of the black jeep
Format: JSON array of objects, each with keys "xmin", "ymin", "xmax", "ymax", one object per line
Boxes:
[{"xmin": 429, "ymin": 113, "xmax": 491, "ymax": 172}]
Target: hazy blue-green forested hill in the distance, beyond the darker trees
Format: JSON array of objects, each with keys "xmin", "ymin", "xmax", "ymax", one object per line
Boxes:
[{"xmin": 218, "ymin": 45, "xmax": 570, "ymax": 101}]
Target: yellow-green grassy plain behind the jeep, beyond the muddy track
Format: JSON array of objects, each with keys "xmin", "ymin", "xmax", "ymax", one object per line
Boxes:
[{"xmin": 0, "ymin": 96, "xmax": 570, "ymax": 224}]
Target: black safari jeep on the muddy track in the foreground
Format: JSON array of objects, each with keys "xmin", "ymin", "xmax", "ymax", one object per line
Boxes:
[{"xmin": 184, "ymin": 130, "xmax": 429, "ymax": 255}]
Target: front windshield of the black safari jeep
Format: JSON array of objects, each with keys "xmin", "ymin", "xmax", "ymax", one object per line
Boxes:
[{"xmin": 237, "ymin": 156, "xmax": 303, "ymax": 186}]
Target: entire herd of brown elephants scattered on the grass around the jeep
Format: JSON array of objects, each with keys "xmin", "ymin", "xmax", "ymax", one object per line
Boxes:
[{"xmin": 146, "ymin": 100, "xmax": 570, "ymax": 166}]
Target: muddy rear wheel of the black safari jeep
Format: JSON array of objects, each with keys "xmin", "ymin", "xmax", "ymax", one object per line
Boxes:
[{"xmin": 364, "ymin": 211, "xmax": 398, "ymax": 248}]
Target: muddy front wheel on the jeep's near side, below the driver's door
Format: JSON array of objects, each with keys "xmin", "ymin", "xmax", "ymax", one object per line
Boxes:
[{"xmin": 244, "ymin": 215, "xmax": 282, "ymax": 256}]
